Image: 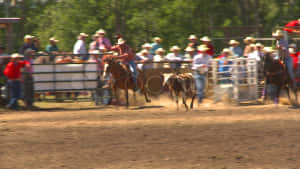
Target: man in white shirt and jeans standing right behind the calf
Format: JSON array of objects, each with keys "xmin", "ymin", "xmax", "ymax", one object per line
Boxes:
[{"xmin": 192, "ymin": 45, "xmax": 212, "ymax": 103}]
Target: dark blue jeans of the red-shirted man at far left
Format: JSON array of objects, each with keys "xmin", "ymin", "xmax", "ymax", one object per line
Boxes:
[{"xmin": 7, "ymin": 80, "xmax": 21, "ymax": 109}]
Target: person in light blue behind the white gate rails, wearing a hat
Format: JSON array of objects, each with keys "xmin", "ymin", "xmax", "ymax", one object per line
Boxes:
[{"xmin": 218, "ymin": 48, "xmax": 233, "ymax": 84}]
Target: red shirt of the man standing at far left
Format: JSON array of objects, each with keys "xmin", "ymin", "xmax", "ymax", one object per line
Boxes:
[{"xmin": 4, "ymin": 61, "xmax": 30, "ymax": 80}]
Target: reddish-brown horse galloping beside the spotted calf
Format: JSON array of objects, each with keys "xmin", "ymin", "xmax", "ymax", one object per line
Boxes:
[{"xmin": 103, "ymin": 55, "xmax": 151, "ymax": 107}]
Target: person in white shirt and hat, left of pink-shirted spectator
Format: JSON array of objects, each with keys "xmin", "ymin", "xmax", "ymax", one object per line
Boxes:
[{"xmin": 73, "ymin": 33, "xmax": 89, "ymax": 60}]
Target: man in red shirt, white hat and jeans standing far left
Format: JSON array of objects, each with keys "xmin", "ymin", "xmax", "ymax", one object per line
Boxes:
[{"xmin": 4, "ymin": 53, "xmax": 30, "ymax": 110}]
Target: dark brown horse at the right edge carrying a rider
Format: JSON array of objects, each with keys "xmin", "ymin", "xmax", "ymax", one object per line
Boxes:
[{"xmin": 263, "ymin": 53, "xmax": 298, "ymax": 105}]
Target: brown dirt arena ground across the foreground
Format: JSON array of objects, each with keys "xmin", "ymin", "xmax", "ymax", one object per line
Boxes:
[{"xmin": 0, "ymin": 100, "xmax": 300, "ymax": 169}]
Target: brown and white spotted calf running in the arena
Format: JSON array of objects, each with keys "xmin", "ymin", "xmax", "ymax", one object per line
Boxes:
[{"xmin": 165, "ymin": 73, "xmax": 196, "ymax": 110}]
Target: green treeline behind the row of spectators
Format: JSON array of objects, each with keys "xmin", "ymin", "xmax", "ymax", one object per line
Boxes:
[{"xmin": 0, "ymin": 0, "xmax": 300, "ymax": 51}]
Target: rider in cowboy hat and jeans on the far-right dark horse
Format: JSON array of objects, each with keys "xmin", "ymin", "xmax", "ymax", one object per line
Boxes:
[{"xmin": 272, "ymin": 30, "xmax": 296, "ymax": 85}]
